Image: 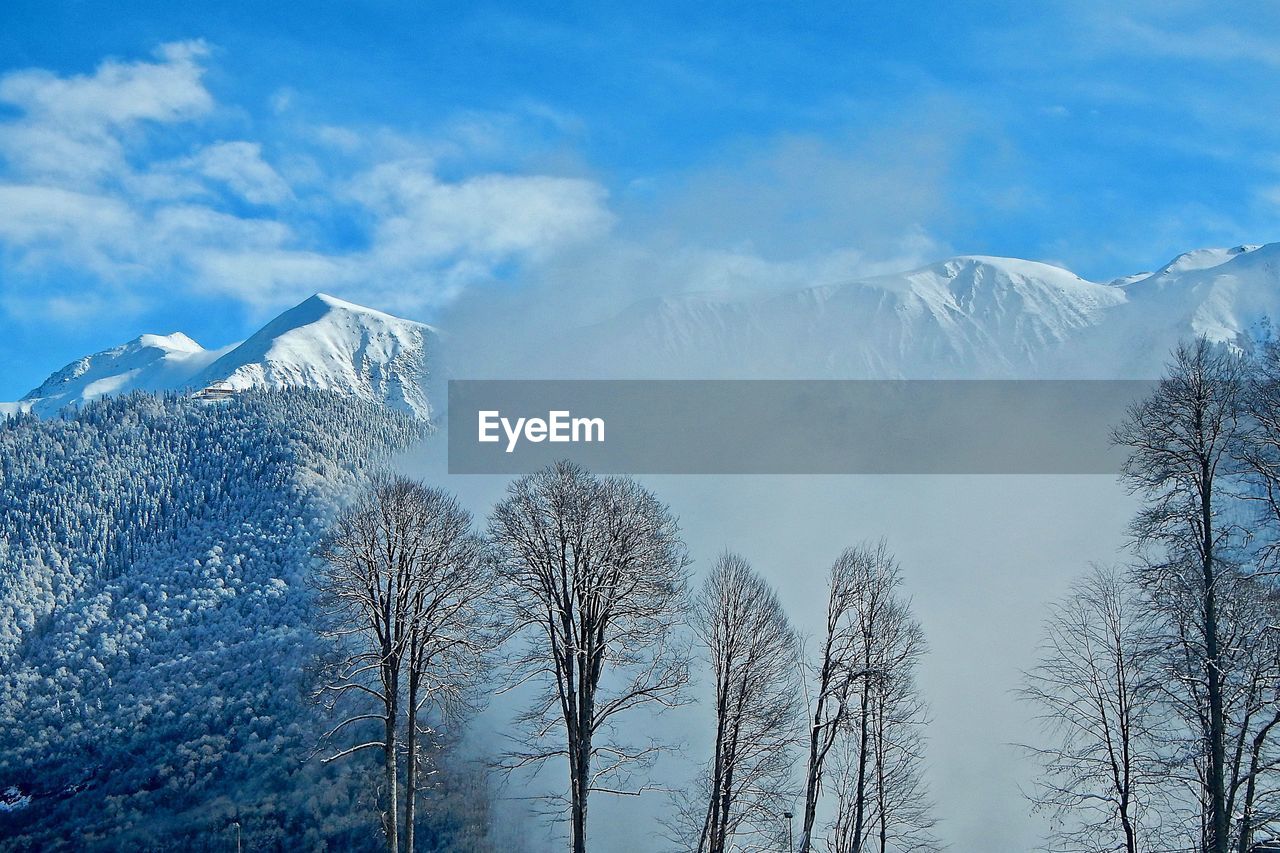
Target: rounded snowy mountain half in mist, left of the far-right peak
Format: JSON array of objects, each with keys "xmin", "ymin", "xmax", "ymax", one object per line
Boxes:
[{"xmin": 578, "ymin": 249, "xmax": 1126, "ymax": 378}]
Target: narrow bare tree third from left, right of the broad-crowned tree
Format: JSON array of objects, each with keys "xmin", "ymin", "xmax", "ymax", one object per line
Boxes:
[{"xmin": 682, "ymin": 552, "xmax": 800, "ymax": 853}]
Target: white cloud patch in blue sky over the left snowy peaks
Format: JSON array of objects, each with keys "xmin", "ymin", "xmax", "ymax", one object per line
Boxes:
[{"xmin": 0, "ymin": 42, "xmax": 612, "ymax": 313}]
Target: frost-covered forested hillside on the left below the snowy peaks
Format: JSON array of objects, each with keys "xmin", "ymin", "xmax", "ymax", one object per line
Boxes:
[{"xmin": 0, "ymin": 389, "xmax": 486, "ymax": 850}]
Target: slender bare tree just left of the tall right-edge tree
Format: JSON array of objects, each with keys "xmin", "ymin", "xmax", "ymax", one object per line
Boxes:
[{"xmin": 1020, "ymin": 567, "xmax": 1171, "ymax": 853}]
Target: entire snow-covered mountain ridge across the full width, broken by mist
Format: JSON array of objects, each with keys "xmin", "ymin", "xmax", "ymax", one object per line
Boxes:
[{"xmin": 0, "ymin": 243, "xmax": 1280, "ymax": 418}]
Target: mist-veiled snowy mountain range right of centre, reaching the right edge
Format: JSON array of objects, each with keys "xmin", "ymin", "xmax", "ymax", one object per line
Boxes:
[{"xmin": 579, "ymin": 243, "xmax": 1280, "ymax": 378}]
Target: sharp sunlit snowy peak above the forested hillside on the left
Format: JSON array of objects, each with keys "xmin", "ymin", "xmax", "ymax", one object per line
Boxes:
[{"xmin": 192, "ymin": 293, "xmax": 435, "ymax": 418}]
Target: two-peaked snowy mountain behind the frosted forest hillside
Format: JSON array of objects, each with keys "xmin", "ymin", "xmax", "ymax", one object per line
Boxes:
[{"xmin": 8, "ymin": 293, "xmax": 435, "ymax": 419}]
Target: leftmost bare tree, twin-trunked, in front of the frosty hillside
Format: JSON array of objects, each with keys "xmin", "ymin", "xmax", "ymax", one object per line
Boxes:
[{"xmin": 317, "ymin": 476, "xmax": 493, "ymax": 853}]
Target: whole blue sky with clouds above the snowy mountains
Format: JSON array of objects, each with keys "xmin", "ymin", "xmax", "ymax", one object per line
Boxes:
[{"xmin": 0, "ymin": 0, "xmax": 1280, "ymax": 400}]
